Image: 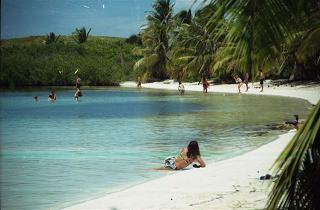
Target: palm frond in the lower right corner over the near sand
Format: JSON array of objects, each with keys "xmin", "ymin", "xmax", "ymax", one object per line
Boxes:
[{"xmin": 267, "ymin": 102, "xmax": 320, "ymax": 209}]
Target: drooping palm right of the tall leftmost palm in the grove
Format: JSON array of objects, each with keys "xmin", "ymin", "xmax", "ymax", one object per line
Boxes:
[{"xmin": 170, "ymin": 5, "xmax": 219, "ymax": 80}]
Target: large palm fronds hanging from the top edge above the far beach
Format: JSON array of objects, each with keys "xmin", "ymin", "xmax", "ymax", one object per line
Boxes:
[{"xmin": 207, "ymin": 0, "xmax": 293, "ymax": 79}]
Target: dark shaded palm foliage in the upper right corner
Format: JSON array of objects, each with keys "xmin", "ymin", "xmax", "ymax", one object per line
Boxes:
[{"xmin": 279, "ymin": 0, "xmax": 320, "ymax": 79}]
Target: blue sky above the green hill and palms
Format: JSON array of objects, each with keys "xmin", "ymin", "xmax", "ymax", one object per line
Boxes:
[{"xmin": 1, "ymin": 0, "xmax": 200, "ymax": 39}]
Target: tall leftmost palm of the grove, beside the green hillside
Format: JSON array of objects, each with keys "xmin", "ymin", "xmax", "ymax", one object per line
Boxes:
[{"xmin": 135, "ymin": 0, "xmax": 173, "ymax": 80}]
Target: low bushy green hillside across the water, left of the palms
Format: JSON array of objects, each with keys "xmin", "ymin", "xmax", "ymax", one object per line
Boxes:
[{"xmin": 0, "ymin": 35, "xmax": 139, "ymax": 87}]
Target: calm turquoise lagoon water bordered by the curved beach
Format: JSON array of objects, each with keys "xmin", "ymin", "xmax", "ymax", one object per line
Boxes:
[{"xmin": 0, "ymin": 88, "xmax": 310, "ymax": 210}]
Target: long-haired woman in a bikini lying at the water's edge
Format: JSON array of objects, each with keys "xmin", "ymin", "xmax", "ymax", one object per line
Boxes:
[{"xmin": 164, "ymin": 141, "xmax": 206, "ymax": 170}]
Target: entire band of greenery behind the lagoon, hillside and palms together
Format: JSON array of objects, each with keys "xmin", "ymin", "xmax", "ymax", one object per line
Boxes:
[{"xmin": 0, "ymin": 0, "xmax": 320, "ymax": 86}]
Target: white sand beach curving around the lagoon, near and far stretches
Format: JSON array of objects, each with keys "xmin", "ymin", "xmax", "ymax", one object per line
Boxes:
[{"xmin": 63, "ymin": 82, "xmax": 320, "ymax": 210}]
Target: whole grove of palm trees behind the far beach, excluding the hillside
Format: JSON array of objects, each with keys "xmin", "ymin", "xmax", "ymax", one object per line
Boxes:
[{"xmin": 135, "ymin": 0, "xmax": 320, "ymax": 80}]
